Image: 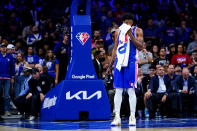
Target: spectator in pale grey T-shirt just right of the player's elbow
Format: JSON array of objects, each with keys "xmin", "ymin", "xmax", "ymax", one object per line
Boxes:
[{"xmin": 138, "ymin": 42, "xmax": 153, "ymax": 75}]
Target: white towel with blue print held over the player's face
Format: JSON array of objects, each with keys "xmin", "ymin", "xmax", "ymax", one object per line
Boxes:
[{"xmin": 116, "ymin": 23, "xmax": 131, "ymax": 71}]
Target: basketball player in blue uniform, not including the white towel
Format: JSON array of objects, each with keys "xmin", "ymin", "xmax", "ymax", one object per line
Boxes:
[{"xmin": 107, "ymin": 13, "xmax": 143, "ymax": 126}]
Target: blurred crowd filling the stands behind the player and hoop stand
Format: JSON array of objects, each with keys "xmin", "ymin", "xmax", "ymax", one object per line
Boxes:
[{"xmin": 0, "ymin": 0, "xmax": 197, "ymax": 120}]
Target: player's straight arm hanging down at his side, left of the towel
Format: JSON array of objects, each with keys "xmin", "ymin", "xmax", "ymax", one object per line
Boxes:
[{"xmin": 107, "ymin": 30, "xmax": 119, "ymax": 73}]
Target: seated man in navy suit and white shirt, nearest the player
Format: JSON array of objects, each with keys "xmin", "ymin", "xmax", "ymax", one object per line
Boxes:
[{"xmin": 146, "ymin": 66, "xmax": 171, "ymax": 119}]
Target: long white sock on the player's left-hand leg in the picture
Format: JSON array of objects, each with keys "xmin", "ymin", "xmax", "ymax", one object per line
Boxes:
[{"xmin": 114, "ymin": 88, "xmax": 123, "ymax": 117}]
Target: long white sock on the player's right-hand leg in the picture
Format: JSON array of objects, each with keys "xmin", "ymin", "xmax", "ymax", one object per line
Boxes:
[{"xmin": 127, "ymin": 88, "xmax": 137, "ymax": 117}]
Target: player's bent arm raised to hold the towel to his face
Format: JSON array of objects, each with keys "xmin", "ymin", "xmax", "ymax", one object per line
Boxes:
[{"xmin": 127, "ymin": 28, "xmax": 144, "ymax": 50}]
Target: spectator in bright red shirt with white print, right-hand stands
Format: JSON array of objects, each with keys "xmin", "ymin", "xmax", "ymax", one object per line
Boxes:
[{"xmin": 171, "ymin": 44, "xmax": 192, "ymax": 66}]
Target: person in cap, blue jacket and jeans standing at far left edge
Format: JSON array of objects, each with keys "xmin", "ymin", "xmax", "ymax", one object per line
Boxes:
[{"xmin": 0, "ymin": 43, "xmax": 15, "ymax": 116}]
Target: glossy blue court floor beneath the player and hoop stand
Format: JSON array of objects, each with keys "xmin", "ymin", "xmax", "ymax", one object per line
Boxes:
[{"xmin": 0, "ymin": 118, "xmax": 197, "ymax": 131}]
